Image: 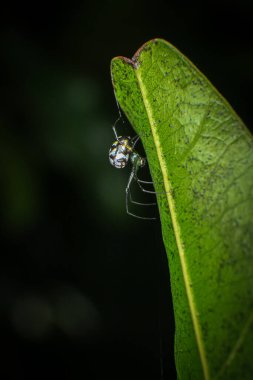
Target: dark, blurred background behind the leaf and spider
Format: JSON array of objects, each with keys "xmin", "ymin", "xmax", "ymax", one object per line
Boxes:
[{"xmin": 0, "ymin": 0, "xmax": 253, "ymax": 380}]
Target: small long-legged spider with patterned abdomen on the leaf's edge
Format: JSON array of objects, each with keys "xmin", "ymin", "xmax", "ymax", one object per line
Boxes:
[{"xmin": 109, "ymin": 123, "xmax": 156, "ymax": 220}]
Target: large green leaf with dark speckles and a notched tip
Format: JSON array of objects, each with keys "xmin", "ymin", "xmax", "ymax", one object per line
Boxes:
[{"xmin": 111, "ymin": 39, "xmax": 253, "ymax": 380}]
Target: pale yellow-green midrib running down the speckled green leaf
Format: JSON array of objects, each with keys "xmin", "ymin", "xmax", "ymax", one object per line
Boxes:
[{"xmin": 133, "ymin": 65, "xmax": 210, "ymax": 380}]
